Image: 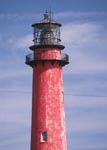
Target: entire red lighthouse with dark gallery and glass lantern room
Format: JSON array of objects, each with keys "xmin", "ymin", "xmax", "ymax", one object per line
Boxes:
[{"xmin": 26, "ymin": 12, "xmax": 69, "ymax": 150}]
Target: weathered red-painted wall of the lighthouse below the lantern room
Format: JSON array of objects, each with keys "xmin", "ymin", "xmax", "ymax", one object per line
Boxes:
[{"xmin": 31, "ymin": 48, "xmax": 67, "ymax": 150}]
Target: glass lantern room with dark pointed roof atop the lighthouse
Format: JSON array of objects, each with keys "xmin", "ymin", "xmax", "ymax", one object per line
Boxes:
[{"xmin": 32, "ymin": 11, "xmax": 61, "ymax": 46}]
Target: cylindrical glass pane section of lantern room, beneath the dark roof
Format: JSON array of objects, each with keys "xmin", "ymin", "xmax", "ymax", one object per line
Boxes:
[{"xmin": 33, "ymin": 24, "xmax": 61, "ymax": 45}]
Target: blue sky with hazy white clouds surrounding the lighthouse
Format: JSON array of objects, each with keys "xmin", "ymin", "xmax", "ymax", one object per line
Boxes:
[{"xmin": 0, "ymin": 0, "xmax": 107, "ymax": 150}]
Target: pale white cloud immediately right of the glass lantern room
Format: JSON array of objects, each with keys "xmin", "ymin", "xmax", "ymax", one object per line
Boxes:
[{"xmin": 62, "ymin": 22, "xmax": 100, "ymax": 46}]
